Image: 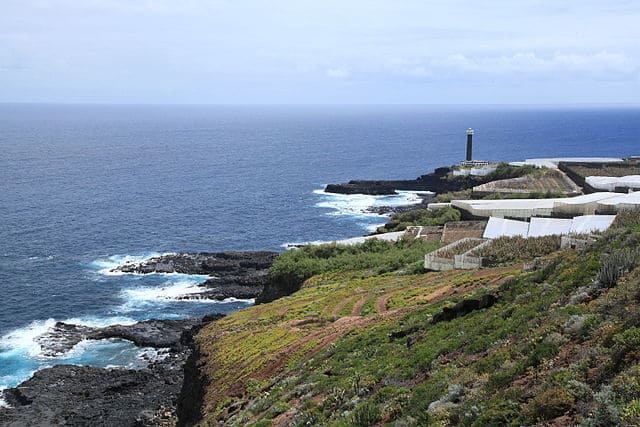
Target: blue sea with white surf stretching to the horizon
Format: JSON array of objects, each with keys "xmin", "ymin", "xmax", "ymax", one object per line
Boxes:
[{"xmin": 0, "ymin": 105, "xmax": 640, "ymax": 394}]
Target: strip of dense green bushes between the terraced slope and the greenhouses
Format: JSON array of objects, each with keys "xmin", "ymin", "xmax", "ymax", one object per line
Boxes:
[{"xmin": 270, "ymin": 238, "xmax": 441, "ymax": 287}]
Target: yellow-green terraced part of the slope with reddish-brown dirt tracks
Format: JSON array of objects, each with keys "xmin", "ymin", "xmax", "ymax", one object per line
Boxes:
[{"xmin": 198, "ymin": 267, "xmax": 519, "ymax": 425}]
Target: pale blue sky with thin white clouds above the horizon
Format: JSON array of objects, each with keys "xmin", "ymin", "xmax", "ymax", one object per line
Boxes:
[{"xmin": 0, "ymin": 0, "xmax": 640, "ymax": 105}]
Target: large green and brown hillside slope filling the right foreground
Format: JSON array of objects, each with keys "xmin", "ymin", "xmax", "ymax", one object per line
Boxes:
[{"xmin": 192, "ymin": 216, "xmax": 640, "ymax": 426}]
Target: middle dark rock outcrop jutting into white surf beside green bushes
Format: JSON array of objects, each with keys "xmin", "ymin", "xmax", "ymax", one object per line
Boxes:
[{"xmin": 113, "ymin": 251, "xmax": 278, "ymax": 300}]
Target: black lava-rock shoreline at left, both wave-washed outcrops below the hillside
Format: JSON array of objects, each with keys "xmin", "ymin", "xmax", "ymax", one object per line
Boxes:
[{"xmin": 0, "ymin": 251, "xmax": 294, "ymax": 426}]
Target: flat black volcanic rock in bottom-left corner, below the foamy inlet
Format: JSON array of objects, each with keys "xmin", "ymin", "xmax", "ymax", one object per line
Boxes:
[{"xmin": 0, "ymin": 365, "xmax": 183, "ymax": 426}]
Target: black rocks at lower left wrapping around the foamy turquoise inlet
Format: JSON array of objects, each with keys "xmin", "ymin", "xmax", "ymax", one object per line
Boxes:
[{"xmin": 0, "ymin": 315, "xmax": 222, "ymax": 426}]
